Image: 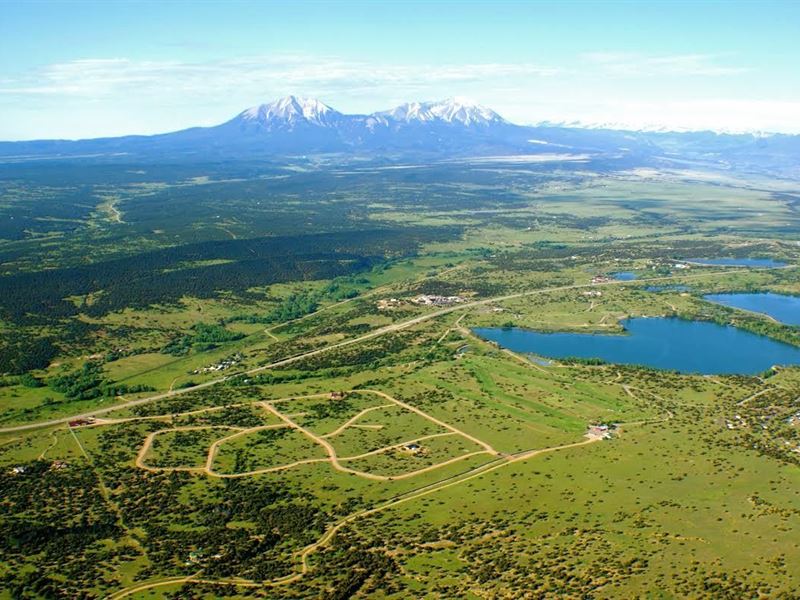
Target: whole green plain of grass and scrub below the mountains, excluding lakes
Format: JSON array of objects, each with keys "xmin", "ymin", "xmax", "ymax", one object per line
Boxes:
[{"xmin": 0, "ymin": 161, "xmax": 800, "ymax": 598}]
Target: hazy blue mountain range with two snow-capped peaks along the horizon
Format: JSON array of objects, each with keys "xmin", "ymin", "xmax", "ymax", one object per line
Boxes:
[{"xmin": 0, "ymin": 96, "xmax": 800, "ymax": 176}]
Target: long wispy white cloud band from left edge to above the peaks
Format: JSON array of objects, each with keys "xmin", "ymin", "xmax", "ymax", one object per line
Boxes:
[{"xmin": 0, "ymin": 55, "xmax": 557, "ymax": 99}]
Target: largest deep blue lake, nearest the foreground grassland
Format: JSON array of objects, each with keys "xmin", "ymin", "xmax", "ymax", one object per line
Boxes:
[{"xmin": 474, "ymin": 318, "xmax": 800, "ymax": 375}]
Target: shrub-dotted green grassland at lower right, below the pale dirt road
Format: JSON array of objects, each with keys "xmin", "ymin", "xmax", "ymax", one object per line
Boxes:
[{"xmin": 344, "ymin": 378, "xmax": 800, "ymax": 597}]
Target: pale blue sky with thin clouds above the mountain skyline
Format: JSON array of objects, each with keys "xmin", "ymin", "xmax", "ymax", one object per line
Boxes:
[{"xmin": 0, "ymin": 0, "xmax": 800, "ymax": 139}]
